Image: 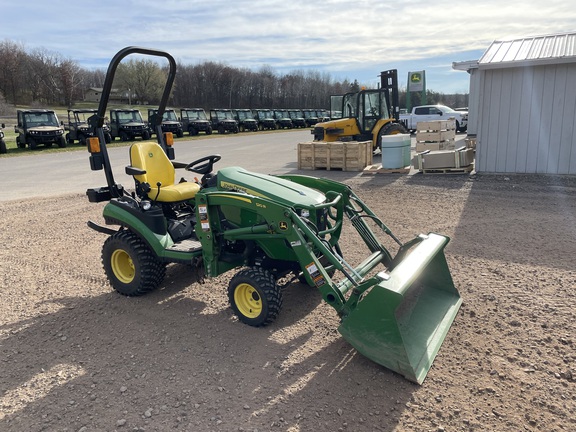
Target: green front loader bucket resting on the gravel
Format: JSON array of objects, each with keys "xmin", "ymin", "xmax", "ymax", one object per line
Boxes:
[{"xmin": 338, "ymin": 233, "xmax": 462, "ymax": 384}]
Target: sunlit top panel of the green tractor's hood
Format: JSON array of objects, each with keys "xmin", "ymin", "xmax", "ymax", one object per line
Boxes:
[{"xmin": 218, "ymin": 167, "xmax": 326, "ymax": 207}]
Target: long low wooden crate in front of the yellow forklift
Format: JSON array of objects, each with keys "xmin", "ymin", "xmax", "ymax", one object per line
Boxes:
[{"xmin": 298, "ymin": 141, "xmax": 372, "ymax": 171}]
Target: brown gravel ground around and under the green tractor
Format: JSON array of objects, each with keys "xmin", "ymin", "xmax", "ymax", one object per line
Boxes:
[{"xmin": 0, "ymin": 172, "xmax": 576, "ymax": 432}]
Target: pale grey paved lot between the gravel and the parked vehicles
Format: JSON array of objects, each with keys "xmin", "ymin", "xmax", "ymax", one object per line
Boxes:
[{"xmin": 0, "ymin": 129, "xmax": 464, "ymax": 201}]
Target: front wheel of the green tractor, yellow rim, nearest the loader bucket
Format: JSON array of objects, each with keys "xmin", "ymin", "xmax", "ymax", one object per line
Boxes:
[{"xmin": 228, "ymin": 267, "xmax": 282, "ymax": 327}]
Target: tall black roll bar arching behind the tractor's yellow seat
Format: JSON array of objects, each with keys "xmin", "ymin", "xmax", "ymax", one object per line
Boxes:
[{"xmin": 96, "ymin": 46, "xmax": 176, "ymax": 198}]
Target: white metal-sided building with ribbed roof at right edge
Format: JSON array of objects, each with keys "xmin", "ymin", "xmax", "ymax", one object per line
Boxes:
[{"xmin": 452, "ymin": 33, "xmax": 576, "ymax": 174}]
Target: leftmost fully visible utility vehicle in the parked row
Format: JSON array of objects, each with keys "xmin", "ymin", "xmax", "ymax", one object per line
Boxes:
[{"xmin": 14, "ymin": 109, "xmax": 66, "ymax": 150}]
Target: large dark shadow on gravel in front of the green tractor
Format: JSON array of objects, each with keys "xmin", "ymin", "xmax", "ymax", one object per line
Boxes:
[{"xmin": 0, "ymin": 276, "xmax": 418, "ymax": 431}]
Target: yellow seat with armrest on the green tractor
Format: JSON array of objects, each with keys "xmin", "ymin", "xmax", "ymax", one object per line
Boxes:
[{"xmin": 130, "ymin": 142, "xmax": 200, "ymax": 202}]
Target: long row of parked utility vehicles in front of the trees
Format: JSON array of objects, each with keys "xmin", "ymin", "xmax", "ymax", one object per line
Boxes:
[{"xmin": 9, "ymin": 108, "xmax": 329, "ymax": 153}]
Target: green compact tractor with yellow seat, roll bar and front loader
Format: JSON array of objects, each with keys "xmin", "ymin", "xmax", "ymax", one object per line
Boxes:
[{"xmin": 87, "ymin": 47, "xmax": 461, "ymax": 383}]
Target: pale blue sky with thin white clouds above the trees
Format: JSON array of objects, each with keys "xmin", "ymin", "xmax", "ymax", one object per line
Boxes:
[{"xmin": 0, "ymin": 0, "xmax": 576, "ymax": 93}]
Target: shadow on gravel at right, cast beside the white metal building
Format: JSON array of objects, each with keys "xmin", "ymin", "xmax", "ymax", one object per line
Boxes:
[{"xmin": 451, "ymin": 175, "xmax": 576, "ymax": 270}]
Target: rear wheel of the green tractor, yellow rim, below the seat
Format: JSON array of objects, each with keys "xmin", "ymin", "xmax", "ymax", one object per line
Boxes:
[{"xmin": 102, "ymin": 230, "xmax": 166, "ymax": 297}]
